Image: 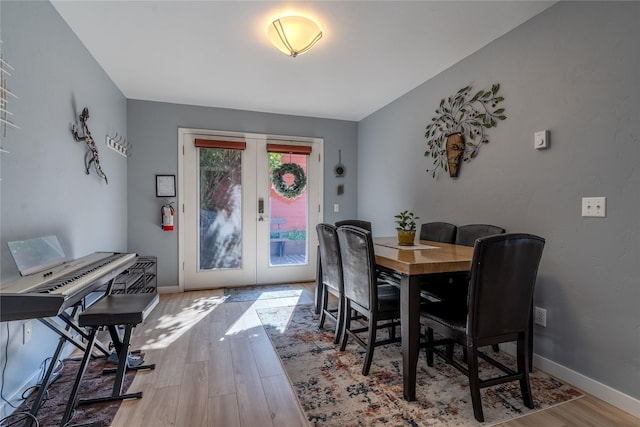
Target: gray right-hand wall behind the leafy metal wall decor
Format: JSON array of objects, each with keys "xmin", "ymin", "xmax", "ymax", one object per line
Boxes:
[{"xmin": 358, "ymin": 2, "xmax": 640, "ymax": 398}]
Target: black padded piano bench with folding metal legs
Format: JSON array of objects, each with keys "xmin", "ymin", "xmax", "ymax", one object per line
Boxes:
[{"xmin": 61, "ymin": 293, "xmax": 160, "ymax": 425}]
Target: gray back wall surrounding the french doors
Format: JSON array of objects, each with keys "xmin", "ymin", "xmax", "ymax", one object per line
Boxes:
[{"xmin": 127, "ymin": 101, "xmax": 358, "ymax": 286}]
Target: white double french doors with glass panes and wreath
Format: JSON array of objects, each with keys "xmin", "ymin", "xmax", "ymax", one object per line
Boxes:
[{"xmin": 178, "ymin": 129, "xmax": 322, "ymax": 290}]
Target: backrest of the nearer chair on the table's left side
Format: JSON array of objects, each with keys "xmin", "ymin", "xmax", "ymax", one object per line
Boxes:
[{"xmin": 338, "ymin": 225, "xmax": 378, "ymax": 310}]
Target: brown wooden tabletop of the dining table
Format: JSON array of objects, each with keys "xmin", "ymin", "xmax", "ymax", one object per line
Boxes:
[{"xmin": 373, "ymin": 237, "xmax": 473, "ymax": 275}]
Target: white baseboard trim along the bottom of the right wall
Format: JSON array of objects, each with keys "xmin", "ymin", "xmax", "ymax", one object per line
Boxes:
[{"xmin": 500, "ymin": 343, "xmax": 640, "ymax": 418}]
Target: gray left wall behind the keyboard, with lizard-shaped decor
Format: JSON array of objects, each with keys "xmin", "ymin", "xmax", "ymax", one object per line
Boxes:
[{"xmin": 0, "ymin": 1, "xmax": 127, "ymax": 414}]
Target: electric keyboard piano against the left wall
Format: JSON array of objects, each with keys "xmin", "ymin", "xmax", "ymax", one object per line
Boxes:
[{"xmin": 0, "ymin": 252, "xmax": 138, "ymax": 322}]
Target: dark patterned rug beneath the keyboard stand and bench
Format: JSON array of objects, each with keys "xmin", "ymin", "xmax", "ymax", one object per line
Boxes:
[{"xmin": 8, "ymin": 358, "xmax": 135, "ymax": 427}]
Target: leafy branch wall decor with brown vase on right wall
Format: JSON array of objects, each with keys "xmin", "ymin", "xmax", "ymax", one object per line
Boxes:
[{"xmin": 424, "ymin": 83, "xmax": 507, "ymax": 178}]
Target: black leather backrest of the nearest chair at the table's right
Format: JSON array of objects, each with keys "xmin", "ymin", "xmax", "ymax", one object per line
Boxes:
[{"xmin": 467, "ymin": 233, "xmax": 545, "ymax": 345}]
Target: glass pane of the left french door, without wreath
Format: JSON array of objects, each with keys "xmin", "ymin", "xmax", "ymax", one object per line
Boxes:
[{"xmin": 198, "ymin": 148, "xmax": 242, "ymax": 270}]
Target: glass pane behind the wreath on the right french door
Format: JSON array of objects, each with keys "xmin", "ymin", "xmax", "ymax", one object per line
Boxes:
[{"xmin": 269, "ymin": 153, "xmax": 308, "ymax": 266}]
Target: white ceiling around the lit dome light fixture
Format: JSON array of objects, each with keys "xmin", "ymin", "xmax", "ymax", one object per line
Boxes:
[{"xmin": 52, "ymin": 0, "xmax": 554, "ymax": 121}]
